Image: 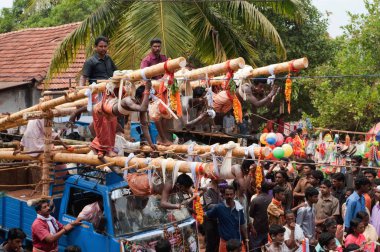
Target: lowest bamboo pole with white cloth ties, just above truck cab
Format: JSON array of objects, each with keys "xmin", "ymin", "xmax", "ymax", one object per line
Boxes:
[{"xmin": 0, "ymin": 151, "xmax": 212, "ymax": 174}]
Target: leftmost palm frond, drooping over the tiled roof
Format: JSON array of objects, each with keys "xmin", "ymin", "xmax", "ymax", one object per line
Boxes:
[{"xmin": 47, "ymin": 0, "xmax": 130, "ymax": 79}]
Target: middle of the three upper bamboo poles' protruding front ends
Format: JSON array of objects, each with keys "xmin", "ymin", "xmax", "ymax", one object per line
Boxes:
[{"xmin": 174, "ymin": 57, "xmax": 245, "ymax": 80}]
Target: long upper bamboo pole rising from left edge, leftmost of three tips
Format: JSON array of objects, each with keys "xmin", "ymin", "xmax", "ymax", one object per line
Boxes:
[{"xmin": 0, "ymin": 57, "xmax": 186, "ymax": 129}]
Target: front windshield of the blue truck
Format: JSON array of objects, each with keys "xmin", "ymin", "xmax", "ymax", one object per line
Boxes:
[{"xmin": 112, "ymin": 189, "xmax": 191, "ymax": 236}]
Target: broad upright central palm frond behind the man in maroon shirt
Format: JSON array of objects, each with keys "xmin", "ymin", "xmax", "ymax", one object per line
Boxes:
[{"xmin": 110, "ymin": 1, "xmax": 193, "ymax": 68}]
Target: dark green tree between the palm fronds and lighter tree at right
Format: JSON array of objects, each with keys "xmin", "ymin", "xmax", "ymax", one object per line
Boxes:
[{"xmin": 252, "ymin": 0, "xmax": 338, "ymax": 121}]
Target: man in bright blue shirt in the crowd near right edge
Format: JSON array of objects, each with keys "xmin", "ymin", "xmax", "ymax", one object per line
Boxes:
[{"xmin": 344, "ymin": 177, "xmax": 371, "ymax": 229}]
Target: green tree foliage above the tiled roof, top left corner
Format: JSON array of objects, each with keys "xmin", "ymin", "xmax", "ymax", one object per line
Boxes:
[{"xmin": 0, "ymin": 0, "xmax": 104, "ymax": 33}]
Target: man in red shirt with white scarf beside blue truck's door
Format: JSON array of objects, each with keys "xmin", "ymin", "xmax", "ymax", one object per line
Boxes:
[{"xmin": 32, "ymin": 199, "xmax": 81, "ymax": 252}]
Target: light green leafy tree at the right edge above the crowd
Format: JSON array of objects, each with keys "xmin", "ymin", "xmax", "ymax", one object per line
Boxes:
[{"xmin": 305, "ymin": 0, "xmax": 380, "ymax": 131}]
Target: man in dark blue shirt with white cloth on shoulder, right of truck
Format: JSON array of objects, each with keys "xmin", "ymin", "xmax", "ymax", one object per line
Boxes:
[{"xmin": 206, "ymin": 186, "xmax": 249, "ymax": 251}]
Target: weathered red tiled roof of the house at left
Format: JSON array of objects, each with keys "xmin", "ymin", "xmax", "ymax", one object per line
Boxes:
[{"xmin": 0, "ymin": 23, "xmax": 85, "ymax": 89}]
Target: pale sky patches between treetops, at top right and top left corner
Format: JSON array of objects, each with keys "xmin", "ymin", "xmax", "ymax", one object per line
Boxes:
[{"xmin": 0, "ymin": 0, "xmax": 365, "ymax": 37}]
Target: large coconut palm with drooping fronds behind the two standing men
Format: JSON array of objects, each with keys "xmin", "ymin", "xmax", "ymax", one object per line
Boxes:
[{"xmin": 46, "ymin": 0, "xmax": 303, "ymax": 78}]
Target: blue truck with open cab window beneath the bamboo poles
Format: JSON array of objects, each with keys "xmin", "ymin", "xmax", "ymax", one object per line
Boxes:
[{"xmin": 0, "ymin": 171, "xmax": 198, "ymax": 252}]
